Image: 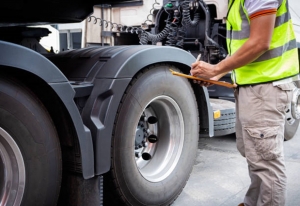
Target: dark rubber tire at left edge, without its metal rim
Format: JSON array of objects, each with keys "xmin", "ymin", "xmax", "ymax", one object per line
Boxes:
[{"xmin": 0, "ymin": 78, "xmax": 62, "ymax": 206}]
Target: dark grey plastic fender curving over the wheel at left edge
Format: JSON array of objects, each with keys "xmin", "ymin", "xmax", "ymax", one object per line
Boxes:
[{"xmin": 0, "ymin": 41, "xmax": 94, "ymax": 179}]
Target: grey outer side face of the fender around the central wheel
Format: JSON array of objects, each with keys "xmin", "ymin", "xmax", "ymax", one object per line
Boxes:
[{"xmin": 82, "ymin": 45, "xmax": 213, "ymax": 174}]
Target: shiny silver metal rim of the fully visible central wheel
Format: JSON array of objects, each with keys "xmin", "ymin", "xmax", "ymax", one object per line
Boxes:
[{"xmin": 134, "ymin": 95, "xmax": 184, "ymax": 182}]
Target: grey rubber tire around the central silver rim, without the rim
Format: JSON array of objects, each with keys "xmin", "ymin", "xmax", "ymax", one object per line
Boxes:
[{"xmin": 104, "ymin": 65, "xmax": 199, "ymax": 206}]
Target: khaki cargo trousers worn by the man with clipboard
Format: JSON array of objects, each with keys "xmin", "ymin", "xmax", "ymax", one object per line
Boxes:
[{"xmin": 235, "ymin": 83, "xmax": 295, "ymax": 206}]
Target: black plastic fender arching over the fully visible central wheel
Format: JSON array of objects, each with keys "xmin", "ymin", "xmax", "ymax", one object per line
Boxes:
[{"xmin": 51, "ymin": 45, "xmax": 213, "ymax": 174}]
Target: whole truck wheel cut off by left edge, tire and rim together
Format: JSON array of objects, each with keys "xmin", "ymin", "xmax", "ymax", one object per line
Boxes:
[{"xmin": 0, "ymin": 78, "xmax": 62, "ymax": 206}]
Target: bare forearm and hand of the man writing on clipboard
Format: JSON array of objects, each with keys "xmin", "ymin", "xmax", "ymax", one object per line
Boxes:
[{"xmin": 191, "ymin": 14, "xmax": 276, "ymax": 80}]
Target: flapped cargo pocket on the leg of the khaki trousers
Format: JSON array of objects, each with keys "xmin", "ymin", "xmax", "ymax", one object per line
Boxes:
[{"xmin": 245, "ymin": 126, "xmax": 283, "ymax": 161}]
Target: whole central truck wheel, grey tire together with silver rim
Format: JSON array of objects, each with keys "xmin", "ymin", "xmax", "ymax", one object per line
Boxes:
[{"xmin": 104, "ymin": 65, "xmax": 199, "ymax": 206}]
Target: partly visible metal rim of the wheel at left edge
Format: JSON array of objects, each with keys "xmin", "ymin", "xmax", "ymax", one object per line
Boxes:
[{"xmin": 0, "ymin": 127, "xmax": 26, "ymax": 206}]
